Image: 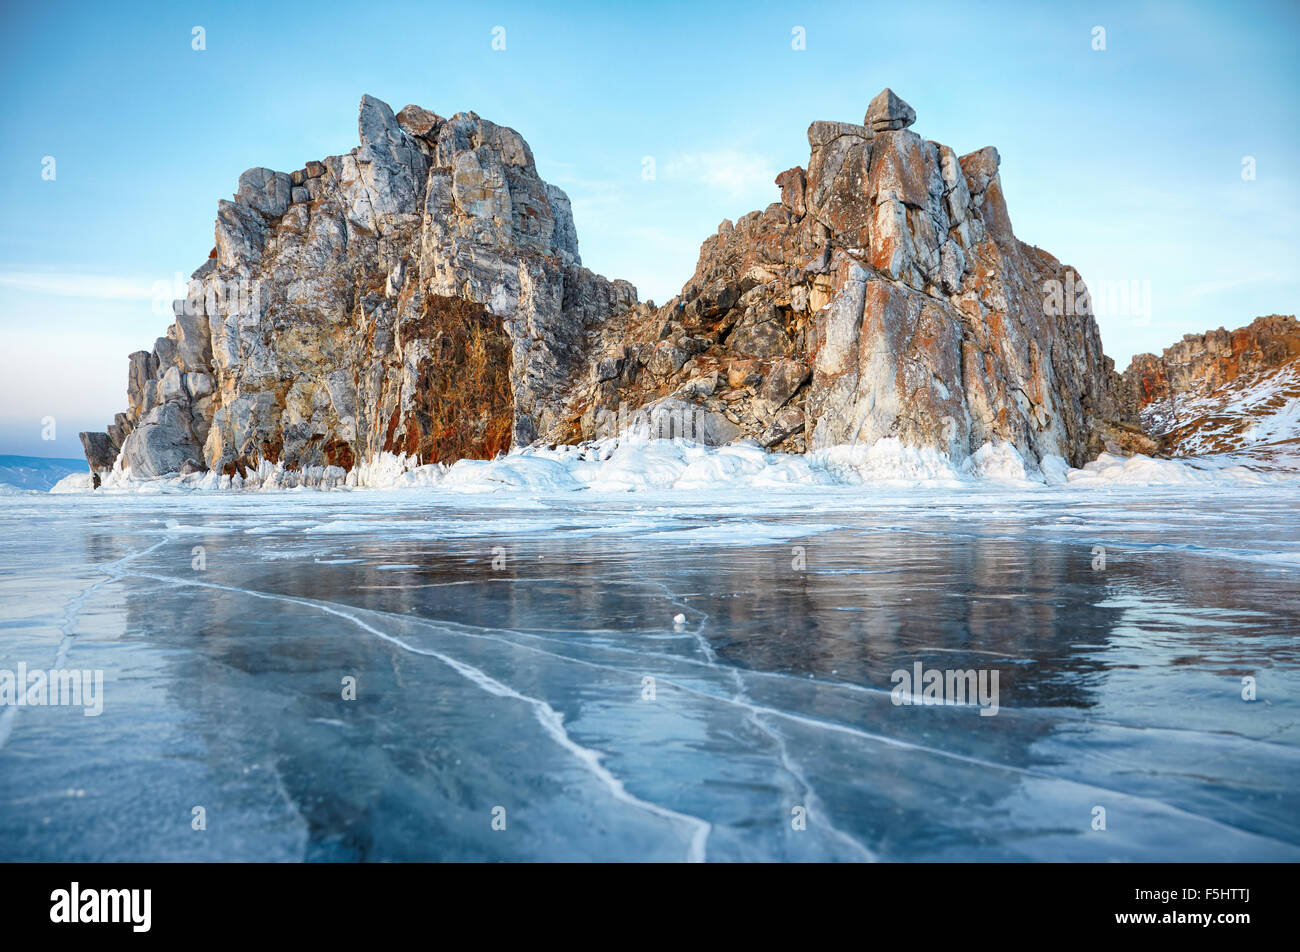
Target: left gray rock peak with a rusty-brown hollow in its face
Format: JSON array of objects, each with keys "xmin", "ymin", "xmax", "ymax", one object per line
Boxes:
[{"xmin": 78, "ymin": 96, "xmax": 636, "ymax": 477}]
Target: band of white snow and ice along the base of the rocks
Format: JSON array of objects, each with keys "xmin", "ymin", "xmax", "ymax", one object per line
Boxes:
[{"xmin": 49, "ymin": 434, "xmax": 1300, "ymax": 494}]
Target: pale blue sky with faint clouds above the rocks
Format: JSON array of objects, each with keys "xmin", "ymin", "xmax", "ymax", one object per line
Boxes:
[{"xmin": 0, "ymin": 0, "xmax": 1300, "ymax": 456}]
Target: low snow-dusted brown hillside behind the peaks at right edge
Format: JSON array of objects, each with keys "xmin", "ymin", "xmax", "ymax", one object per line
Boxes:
[{"xmin": 1122, "ymin": 315, "xmax": 1300, "ymax": 458}]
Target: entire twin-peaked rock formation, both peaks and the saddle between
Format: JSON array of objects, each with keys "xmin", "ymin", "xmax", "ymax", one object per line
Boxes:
[{"xmin": 83, "ymin": 90, "xmax": 1134, "ymax": 477}]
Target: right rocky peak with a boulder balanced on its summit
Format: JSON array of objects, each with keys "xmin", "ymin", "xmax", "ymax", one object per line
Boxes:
[{"xmin": 545, "ymin": 90, "xmax": 1140, "ymax": 464}]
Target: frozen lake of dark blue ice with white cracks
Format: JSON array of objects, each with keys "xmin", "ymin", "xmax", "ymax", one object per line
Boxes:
[{"xmin": 0, "ymin": 486, "xmax": 1300, "ymax": 861}]
